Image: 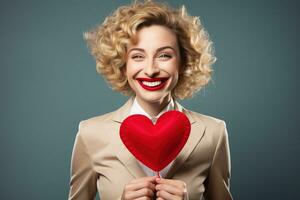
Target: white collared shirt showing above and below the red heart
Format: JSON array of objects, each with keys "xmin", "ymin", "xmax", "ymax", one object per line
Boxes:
[{"xmin": 129, "ymin": 98, "xmax": 175, "ymax": 178}]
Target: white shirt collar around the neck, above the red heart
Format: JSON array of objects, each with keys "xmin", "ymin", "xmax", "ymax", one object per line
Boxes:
[{"xmin": 130, "ymin": 97, "xmax": 175, "ymax": 121}]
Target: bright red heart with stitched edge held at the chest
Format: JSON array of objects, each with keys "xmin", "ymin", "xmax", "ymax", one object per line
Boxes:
[{"xmin": 120, "ymin": 110, "xmax": 191, "ymax": 172}]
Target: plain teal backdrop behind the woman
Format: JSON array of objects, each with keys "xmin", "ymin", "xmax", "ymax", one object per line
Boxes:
[{"xmin": 0, "ymin": 0, "xmax": 300, "ymax": 200}]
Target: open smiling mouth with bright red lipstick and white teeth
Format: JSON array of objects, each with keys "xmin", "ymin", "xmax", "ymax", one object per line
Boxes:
[{"xmin": 136, "ymin": 77, "xmax": 169, "ymax": 91}]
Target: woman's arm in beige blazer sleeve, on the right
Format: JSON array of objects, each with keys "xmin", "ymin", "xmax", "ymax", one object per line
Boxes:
[{"xmin": 204, "ymin": 122, "xmax": 232, "ymax": 200}]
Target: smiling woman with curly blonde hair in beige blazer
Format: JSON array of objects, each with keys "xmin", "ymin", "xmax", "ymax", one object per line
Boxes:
[{"xmin": 69, "ymin": 1, "xmax": 232, "ymax": 200}]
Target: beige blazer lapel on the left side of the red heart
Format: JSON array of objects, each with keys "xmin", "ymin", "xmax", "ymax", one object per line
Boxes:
[{"xmin": 113, "ymin": 98, "xmax": 147, "ymax": 178}]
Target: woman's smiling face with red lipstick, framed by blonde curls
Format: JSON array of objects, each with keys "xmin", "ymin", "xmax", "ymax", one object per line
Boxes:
[{"xmin": 125, "ymin": 25, "xmax": 180, "ymax": 104}]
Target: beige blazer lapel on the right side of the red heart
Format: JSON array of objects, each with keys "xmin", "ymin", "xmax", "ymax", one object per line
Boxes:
[{"xmin": 165, "ymin": 102, "xmax": 205, "ymax": 179}]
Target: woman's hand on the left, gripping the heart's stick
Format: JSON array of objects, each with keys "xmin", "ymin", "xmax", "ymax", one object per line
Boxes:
[{"xmin": 122, "ymin": 176, "xmax": 156, "ymax": 200}]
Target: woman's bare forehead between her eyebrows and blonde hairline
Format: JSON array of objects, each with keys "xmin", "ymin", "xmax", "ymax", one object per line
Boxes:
[{"xmin": 129, "ymin": 25, "xmax": 178, "ymax": 49}]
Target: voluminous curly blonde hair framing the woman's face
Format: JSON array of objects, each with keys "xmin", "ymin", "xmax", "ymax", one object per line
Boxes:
[{"xmin": 84, "ymin": 1, "xmax": 216, "ymax": 99}]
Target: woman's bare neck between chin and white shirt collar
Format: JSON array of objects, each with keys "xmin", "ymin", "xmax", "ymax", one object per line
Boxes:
[{"xmin": 137, "ymin": 95, "xmax": 171, "ymax": 117}]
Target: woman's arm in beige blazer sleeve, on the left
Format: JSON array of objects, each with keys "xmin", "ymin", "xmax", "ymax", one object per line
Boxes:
[{"xmin": 69, "ymin": 124, "xmax": 97, "ymax": 200}]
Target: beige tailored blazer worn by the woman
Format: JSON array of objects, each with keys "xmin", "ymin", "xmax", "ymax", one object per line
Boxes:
[{"xmin": 69, "ymin": 98, "xmax": 232, "ymax": 200}]
